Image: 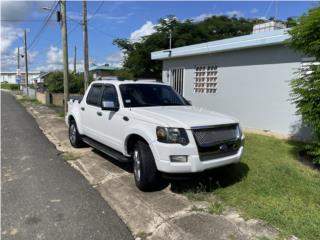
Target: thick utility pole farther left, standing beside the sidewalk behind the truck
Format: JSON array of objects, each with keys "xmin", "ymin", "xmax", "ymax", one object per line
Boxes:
[{"xmin": 60, "ymin": 0, "xmax": 69, "ymax": 113}]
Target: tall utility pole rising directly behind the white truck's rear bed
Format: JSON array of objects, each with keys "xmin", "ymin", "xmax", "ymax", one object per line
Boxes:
[{"xmin": 82, "ymin": 0, "xmax": 89, "ymax": 90}]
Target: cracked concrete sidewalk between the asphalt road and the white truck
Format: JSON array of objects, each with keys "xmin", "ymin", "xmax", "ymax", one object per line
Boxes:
[{"xmin": 18, "ymin": 94, "xmax": 278, "ymax": 240}]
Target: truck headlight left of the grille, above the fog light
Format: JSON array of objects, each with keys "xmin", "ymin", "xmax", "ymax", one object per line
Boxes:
[{"xmin": 156, "ymin": 127, "xmax": 189, "ymax": 145}]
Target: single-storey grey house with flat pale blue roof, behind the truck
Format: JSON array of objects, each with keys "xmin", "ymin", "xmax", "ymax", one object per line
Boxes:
[{"xmin": 151, "ymin": 24, "xmax": 311, "ymax": 139}]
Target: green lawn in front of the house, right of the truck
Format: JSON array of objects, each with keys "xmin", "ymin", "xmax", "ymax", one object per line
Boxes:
[{"xmin": 175, "ymin": 134, "xmax": 320, "ymax": 240}]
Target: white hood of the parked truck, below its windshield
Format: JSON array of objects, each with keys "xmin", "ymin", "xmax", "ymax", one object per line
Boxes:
[{"xmin": 132, "ymin": 106, "xmax": 238, "ymax": 129}]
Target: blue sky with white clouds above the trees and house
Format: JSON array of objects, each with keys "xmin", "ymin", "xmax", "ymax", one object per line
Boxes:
[{"xmin": 0, "ymin": 0, "xmax": 317, "ymax": 71}]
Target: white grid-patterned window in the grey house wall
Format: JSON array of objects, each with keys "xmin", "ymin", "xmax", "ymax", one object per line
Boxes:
[{"xmin": 193, "ymin": 65, "xmax": 218, "ymax": 94}]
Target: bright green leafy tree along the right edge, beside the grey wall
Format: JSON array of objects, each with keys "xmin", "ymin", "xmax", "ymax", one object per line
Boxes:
[{"xmin": 289, "ymin": 6, "xmax": 320, "ymax": 164}]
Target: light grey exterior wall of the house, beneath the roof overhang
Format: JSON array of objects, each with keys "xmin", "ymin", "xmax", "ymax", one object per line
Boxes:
[{"xmin": 162, "ymin": 45, "xmax": 311, "ymax": 139}]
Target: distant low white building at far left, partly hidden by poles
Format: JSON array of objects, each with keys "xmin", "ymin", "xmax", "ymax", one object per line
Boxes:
[{"xmin": 0, "ymin": 71, "xmax": 45, "ymax": 84}]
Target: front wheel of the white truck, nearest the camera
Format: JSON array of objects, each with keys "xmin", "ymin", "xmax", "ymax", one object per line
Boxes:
[{"xmin": 132, "ymin": 141, "xmax": 161, "ymax": 191}]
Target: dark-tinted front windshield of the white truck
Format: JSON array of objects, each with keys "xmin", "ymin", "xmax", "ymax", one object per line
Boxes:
[{"xmin": 120, "ymin": 84, "xmax": 186, "ymax": 107}]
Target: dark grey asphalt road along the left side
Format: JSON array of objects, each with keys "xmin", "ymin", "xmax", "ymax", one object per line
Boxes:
[{"xmin": 1, "ymin": 91, "xmax": 133, "ymax": 240}]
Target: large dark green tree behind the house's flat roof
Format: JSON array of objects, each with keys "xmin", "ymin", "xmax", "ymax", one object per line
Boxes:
[{"xmin": 113, "ymin": 16, "xmax": 257, "ymax": 79}]
